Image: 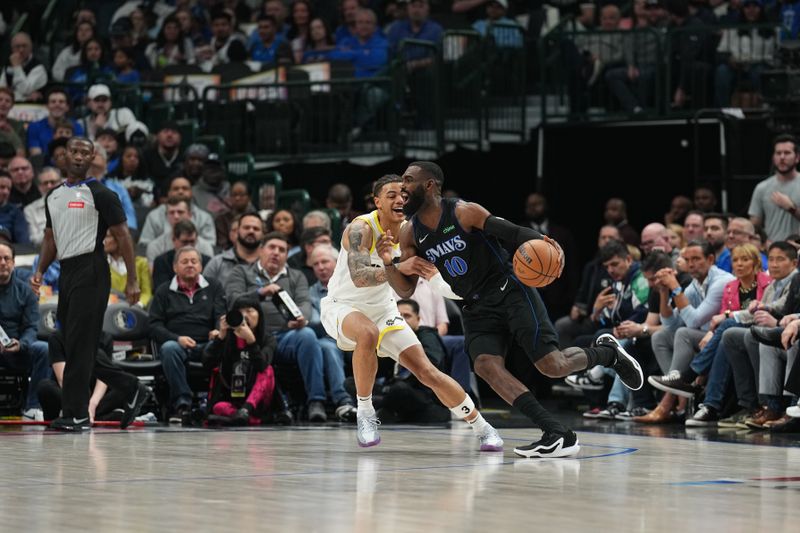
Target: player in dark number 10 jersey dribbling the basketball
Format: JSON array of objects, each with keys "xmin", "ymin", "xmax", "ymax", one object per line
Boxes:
[{"xmin": 377, "ymin": 161, "xmax": 643, "ymax": 457}]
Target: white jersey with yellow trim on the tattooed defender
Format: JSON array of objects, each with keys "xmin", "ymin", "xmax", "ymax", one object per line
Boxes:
[{"xmin": 327, "ymin": 211, "xmax": 406, "ymax": 307}]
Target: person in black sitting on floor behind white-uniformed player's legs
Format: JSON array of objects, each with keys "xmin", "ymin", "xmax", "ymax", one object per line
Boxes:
[{"xmin": 379, "ymin": 300, "xmax": 450, "ymax": 423}]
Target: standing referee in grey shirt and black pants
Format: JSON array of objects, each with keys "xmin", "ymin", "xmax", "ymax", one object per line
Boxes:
[{"xmin": 31, "ymin": 137, "xmax": 139, "ymax": 431}]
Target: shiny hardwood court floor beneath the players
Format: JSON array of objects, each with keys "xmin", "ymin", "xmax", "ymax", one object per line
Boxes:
[{"xmin": 0, "ymin": 423, "xmax": 800, "ymax": 533}]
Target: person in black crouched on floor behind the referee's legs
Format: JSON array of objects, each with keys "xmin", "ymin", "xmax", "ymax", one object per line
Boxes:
[{"xmin": 36, "ymin": 330, "xmax": 150, "ymax": 429}]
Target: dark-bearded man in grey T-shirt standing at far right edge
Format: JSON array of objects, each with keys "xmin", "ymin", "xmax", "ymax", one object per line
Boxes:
[{"xmin": 747, "ymin": 135, "xmax": 800, "ymax": 241}]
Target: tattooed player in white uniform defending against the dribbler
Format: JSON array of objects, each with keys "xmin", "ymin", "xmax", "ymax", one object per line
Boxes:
[{"xmin": 320, "ymin": 175, "xmax": 503, "ymax": 451}]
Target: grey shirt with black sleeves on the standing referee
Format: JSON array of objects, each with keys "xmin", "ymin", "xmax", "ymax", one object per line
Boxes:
[{"xmin": 45, "ymin": 178, "xmax": 126, "ymax": 261}]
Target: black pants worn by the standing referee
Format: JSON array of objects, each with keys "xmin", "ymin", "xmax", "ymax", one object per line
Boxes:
[{"xmin": 58, "ymin": 253, "xmax": 111, "ymax": 418}]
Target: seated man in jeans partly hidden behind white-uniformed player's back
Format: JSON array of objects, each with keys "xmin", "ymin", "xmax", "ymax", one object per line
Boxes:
[{"xmin": 308, "ymin": 244, "xmax": 356, "ymax": 422}]
